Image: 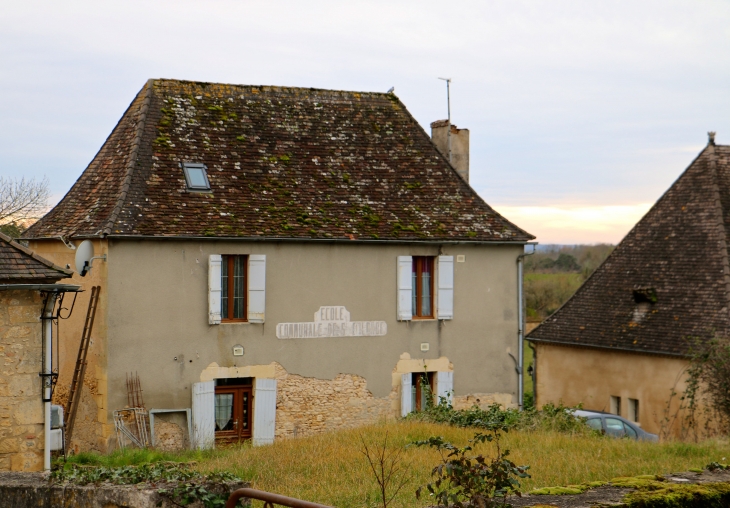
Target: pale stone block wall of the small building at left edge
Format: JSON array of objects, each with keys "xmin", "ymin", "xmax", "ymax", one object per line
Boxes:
[{"xmin": 0, "ymin": 290, "xmax": 43, "ymax": 471}]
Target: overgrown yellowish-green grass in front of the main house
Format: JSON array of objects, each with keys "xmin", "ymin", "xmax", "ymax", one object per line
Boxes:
[{"xmin": 68, "ymin": 421, "xmax": 730, "ymax": 508}]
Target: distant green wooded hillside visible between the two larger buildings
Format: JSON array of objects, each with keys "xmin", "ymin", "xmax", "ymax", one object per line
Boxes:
[{"xmin": 525, "ymin": 244, "xmax": 615, "ymax": 321}]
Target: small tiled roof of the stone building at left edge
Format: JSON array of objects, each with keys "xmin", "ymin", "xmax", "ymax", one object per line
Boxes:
[{"xmin": 0, "ymin": 233, "xmax": 73, "ymax": 284}]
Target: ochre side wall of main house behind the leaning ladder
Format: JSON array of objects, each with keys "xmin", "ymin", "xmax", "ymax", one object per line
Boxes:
[{"xmin": 28, "ymin": 239, "xmax": 109, "ymax": 451}]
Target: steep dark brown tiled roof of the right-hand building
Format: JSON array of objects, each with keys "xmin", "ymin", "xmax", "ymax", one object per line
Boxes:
[{"xmin": 528, "ymin": 143, "xmax": 730, "ymax": 355}]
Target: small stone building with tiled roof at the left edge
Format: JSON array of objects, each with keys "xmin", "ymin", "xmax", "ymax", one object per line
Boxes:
[{"xmin": 0, "ymin": 233, "xmax": 73, "ymax": 471}]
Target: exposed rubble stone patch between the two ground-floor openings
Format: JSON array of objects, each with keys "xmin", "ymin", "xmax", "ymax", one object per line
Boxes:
[{"xmin": 275, "ymin": 363, "xmax": 397, "ymax": 438}]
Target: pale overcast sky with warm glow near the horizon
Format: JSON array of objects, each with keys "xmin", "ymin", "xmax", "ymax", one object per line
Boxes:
[{"xmin": 0, "ymin": 0, "xmax": 730, "ymax": 243}]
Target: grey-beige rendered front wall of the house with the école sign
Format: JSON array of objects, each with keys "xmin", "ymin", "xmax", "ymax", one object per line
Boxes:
[{"xmin": 108, "ymin": 240, "xmax": 522, "ymax": 424}]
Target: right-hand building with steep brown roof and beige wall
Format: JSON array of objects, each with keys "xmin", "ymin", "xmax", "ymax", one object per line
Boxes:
[{"xmin": 527, "ymin": 133, "xmax": 730, "ymax": 436}]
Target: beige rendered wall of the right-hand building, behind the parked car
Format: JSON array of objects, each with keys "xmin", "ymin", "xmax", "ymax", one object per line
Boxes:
[{"xmin": 536, "ymin": 343, "xmax": 687, "ymax": 436}]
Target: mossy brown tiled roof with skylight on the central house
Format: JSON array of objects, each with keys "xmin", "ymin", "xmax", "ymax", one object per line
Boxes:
[{"xmin": 25, "ymin": 80, "xmax": 534, "ymax": 242}]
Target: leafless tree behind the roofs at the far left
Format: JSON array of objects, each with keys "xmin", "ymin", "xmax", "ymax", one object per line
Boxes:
[{"xmin": 0, "ymin": 176, "xmax": 50, "ymax": 224}]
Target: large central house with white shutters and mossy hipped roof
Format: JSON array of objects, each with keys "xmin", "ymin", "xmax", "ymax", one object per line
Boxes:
[{"xmin": 25, "ymin": 80, "xmax": 534, "ymax": 450}]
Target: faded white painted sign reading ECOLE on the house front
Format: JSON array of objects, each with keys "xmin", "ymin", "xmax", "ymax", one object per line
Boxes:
[{"xmin": 276, "ymin": 306, "xmax": 388, "ymax": 339}]
